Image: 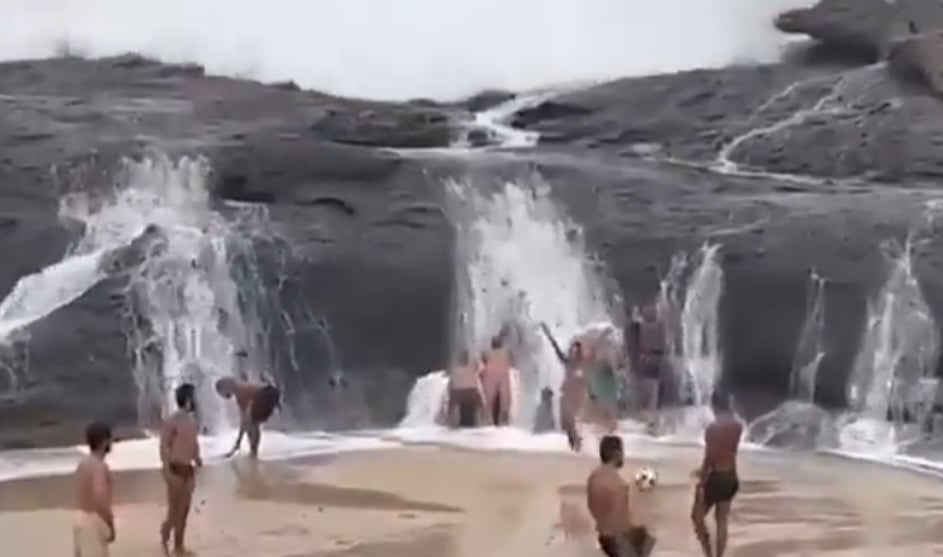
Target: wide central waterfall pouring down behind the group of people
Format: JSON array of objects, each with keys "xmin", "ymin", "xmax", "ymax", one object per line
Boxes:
[{"xmin": 404, "ymin": 179, "xmax": 611, "ymax": 428}]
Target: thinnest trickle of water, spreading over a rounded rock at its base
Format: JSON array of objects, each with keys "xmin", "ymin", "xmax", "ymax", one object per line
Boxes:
[{"xmin": 745, "ymin": 269, "xmax": 831, "ymax": 448}]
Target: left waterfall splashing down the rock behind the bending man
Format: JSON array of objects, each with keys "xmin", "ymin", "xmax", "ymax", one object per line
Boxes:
[{"xmin": 62, "ymin": 157, "xmax": 268, "ymax": 432}]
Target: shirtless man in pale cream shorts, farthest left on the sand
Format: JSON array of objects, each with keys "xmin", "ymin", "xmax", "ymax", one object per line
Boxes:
[{"xmin": 72, "ymin": 422, "xmax": 115, "ymax": 557}]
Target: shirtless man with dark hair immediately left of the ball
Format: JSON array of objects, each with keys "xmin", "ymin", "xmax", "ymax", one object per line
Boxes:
[{"xmin": 586, "ymin": 435, "xmax": 655, "ymax": 557}]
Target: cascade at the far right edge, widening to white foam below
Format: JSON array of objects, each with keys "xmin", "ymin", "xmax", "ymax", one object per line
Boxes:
[{"xmin": 839, "ymin": 237, "xmax": 939, "ymax": 453}]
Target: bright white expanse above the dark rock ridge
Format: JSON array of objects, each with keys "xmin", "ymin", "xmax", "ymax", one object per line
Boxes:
[{"xmin": 0, "ymin": 0, "xmax": 812, "ymax": 99}]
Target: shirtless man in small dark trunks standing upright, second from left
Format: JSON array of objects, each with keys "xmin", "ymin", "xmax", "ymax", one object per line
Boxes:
[{"xmin": 160, "ymin": 383, "xmax": 203, "ymax": 555}]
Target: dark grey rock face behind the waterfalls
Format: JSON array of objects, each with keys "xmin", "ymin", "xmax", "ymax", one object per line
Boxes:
[{"xmin": 0, "ymin": 11, "xmax": 943, "ymax": 446}]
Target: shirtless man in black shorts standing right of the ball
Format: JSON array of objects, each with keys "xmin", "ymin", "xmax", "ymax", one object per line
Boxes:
[{"xmin": 691, "ymin": 392, "xmax": 743, "ymax": 557}]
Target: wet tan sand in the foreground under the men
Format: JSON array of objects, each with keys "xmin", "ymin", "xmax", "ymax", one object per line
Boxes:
[{"xmin": 0, "ymin": 446, "xmax": 943, "ymax": 557}]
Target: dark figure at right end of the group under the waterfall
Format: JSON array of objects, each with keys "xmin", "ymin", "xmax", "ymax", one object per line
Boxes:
[{"xmin": 626, "ymin": 304, "xmax": 667, "ymax": 433}]
